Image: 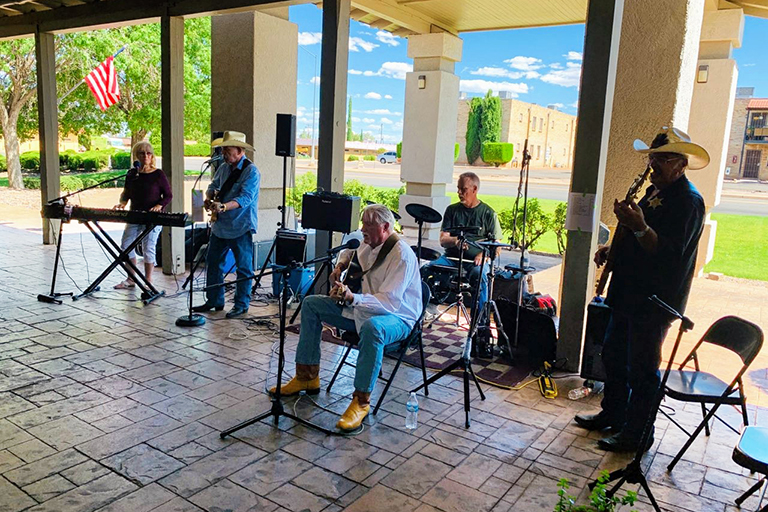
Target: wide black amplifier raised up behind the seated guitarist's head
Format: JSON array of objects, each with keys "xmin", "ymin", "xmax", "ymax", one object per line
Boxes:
[{"xmin": 301, "ymin": 192, "xmax": 360, "ymax": 233}]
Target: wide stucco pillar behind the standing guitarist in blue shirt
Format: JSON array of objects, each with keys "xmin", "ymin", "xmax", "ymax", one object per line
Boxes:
[{"xmin": 211, "ymin": 10, "xmax": 298, "ymax": 241}]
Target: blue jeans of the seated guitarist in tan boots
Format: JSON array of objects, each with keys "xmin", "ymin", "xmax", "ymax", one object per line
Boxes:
[{"xmin": 296, "ymin": 295, "xmax": 411, "ymax": 393}]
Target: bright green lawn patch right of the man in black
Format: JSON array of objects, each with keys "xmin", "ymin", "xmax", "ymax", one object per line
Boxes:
[{"xmin": 704, "ymin": 213, "xmax": 768, "ymax": 281}]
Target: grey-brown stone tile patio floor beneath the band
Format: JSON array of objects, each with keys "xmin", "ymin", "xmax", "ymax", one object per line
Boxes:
[{"xmin": 0, "ymin": 225, "xmax": 768, "ymax": 512}]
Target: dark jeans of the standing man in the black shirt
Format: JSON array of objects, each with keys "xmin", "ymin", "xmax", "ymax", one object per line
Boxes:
[{"xmin": 601, "ymin": 311, "xmax": 669, "ymax": 438}]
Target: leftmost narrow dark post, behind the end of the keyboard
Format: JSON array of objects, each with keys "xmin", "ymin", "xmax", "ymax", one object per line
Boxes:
[{"xmin": 35, "ymin": 30, "xmax": 61, "ymax": 244}]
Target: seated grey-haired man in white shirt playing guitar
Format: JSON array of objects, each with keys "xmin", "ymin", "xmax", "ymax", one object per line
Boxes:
[{"xmin": 271, "ymin": 204, "xmax": 422, "ymax": 430}]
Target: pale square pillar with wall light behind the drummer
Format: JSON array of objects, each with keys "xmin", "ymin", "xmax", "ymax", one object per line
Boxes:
[{"xmin": 400, "ymin": 33, "xmax": 460, "ymax": 240}]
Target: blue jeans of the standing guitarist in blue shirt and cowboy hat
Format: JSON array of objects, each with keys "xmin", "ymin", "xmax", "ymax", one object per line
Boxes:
[{"xmin": 205, "ymin": 232, "xmax": 253, "ymax": 309}]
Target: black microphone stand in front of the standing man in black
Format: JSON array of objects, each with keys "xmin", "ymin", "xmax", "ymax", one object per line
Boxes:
[{"xmin": 589, "ymin": 295, "xmax": 693, "ymax": 512}]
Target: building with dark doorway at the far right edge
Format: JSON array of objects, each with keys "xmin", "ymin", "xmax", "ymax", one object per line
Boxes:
[{"xmin": 726, "ymin": 87, "xmax": 768, "ymax": 180}]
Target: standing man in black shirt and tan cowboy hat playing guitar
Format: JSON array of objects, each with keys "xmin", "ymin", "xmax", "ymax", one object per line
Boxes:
[{"xmin": 575, "ymin": 127, "xmax": 709, "ymax": 452}]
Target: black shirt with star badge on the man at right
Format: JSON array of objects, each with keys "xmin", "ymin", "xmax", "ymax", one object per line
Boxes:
[{"xmin": 606, "ymin": 175, "xmax": 705, "ymax": 314}]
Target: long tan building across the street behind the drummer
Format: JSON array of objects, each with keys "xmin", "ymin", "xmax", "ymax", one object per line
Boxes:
[{"xmin": 456, "ymin": 92, "xmax": 576, "ymax": 169}]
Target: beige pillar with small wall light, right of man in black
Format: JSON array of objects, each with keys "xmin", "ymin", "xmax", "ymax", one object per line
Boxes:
[{"xmin": 687, "ymin": 9, "xmax": 744, "ymax": 272}]
